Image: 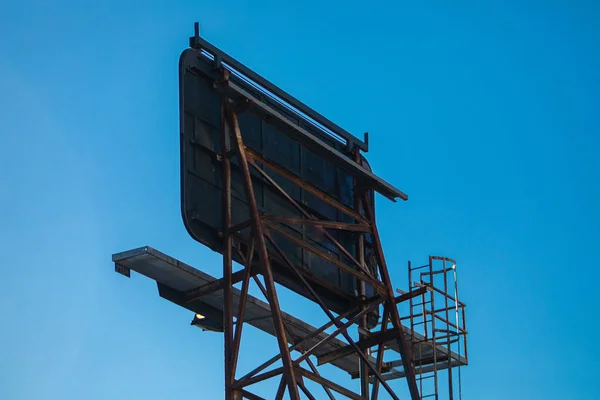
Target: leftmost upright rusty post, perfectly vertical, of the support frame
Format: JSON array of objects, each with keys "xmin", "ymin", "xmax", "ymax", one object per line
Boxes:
[{"xmin": 221, "ymin": 75, "xmax": 235, "ymax": 400}]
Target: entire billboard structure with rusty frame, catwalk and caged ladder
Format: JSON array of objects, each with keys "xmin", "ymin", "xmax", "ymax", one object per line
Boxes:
[{"xmin": 113, "ymin": 24, "xmax": 467, "ymax": 400}]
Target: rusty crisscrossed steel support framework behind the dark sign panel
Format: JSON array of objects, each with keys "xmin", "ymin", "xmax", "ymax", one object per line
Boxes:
[{"xmin": 218, "ymin": 70, "xmax": 420, "ymax": 400}]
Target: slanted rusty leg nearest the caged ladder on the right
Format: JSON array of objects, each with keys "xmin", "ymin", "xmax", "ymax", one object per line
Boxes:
[{"xmin": 363, "ymin": 193, "xmax": 421, "ymax": 400}]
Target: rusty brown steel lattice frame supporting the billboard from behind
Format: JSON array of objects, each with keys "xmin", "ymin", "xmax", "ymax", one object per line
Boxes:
[{"xmin": 204, "ymin": 69, "xmax": 426, "ymax": 400}]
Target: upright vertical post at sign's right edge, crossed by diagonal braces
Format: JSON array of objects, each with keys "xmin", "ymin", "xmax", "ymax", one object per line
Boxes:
[{"xmin": 354, "ymin": 150, "xmax": 371, "ymax": 400}]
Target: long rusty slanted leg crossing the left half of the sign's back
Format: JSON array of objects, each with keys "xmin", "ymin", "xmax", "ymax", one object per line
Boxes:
[{"xmin": 225, "ymin": 103, "xmax": 300, "ymax": 400}]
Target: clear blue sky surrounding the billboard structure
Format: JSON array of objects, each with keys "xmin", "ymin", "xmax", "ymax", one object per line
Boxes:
[{"xmin": 0, "ymin": 0, "xmax": 600, "ymax": 400}]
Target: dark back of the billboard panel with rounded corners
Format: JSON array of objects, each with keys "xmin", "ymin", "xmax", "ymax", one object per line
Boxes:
[{"xmin": 179, "ymin": 41, "xmax": 401, "ymax": 317}]
